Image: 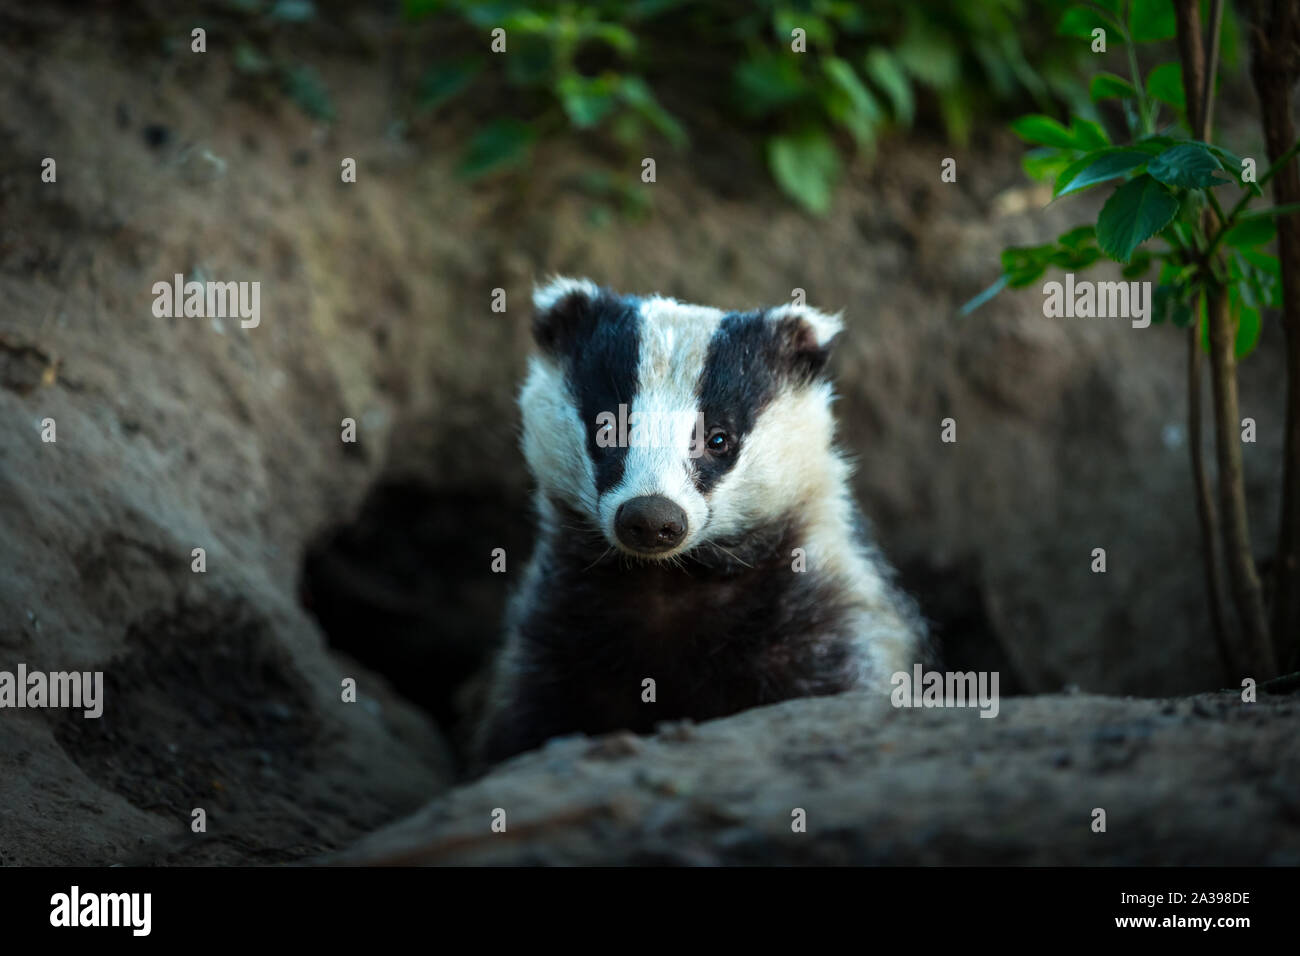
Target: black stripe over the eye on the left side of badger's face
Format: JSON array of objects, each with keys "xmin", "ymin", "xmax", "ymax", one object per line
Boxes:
[{"xmin": 553, "ymin": 291, "xmax": 641, "ymax": 494}]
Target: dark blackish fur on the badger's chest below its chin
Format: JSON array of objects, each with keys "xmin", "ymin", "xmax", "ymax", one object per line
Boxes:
[{"xmin": 482, "ymin": 509, "xmax": 852, "ymax": 762}]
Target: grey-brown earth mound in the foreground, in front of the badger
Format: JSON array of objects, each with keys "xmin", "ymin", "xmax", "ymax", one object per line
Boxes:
[{"xmin": 334, "ymin": 692, "xmax": 1300, "ymax": 866}]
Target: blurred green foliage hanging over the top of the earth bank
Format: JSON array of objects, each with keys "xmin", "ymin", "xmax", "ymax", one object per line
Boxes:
[{"xmin": 402, "ymin": 0, "xmax": 1091, "ymax": 213}]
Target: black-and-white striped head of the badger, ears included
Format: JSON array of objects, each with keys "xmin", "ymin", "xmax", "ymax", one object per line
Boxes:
[{"xmin": 520, "ymin": 278, "xmax": 846, "ymax": 561}]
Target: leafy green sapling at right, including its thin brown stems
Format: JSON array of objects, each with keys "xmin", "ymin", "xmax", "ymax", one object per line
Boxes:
[{"xmin": 962, "ymin": 0, "xmax": 1300, "ymax": 678}]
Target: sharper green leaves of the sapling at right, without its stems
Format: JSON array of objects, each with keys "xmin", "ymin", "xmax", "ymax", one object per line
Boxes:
[{"xmin": 962, "ymin": 0, "xmax": 1300, "ymax": 358}]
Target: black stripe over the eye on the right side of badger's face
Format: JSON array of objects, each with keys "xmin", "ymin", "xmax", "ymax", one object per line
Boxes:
[{"xmin": 693, "ymin": 311, "xmax": 784, "ymax": 494}]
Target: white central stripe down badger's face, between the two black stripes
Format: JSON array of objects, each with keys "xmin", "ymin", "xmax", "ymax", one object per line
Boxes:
[{"xmin": 601, "ymin": 297, "xmax": 724, "ymax": 550}]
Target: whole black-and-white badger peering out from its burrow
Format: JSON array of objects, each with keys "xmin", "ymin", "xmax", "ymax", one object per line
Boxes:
[{"xmin": 476, "ymin": 278, "xmax": 927, "ymax": 765}]
